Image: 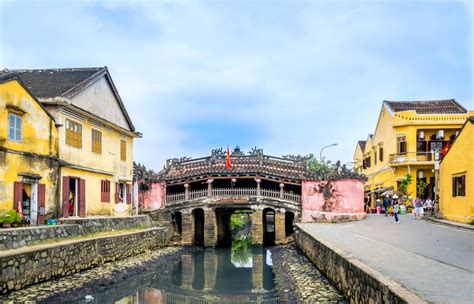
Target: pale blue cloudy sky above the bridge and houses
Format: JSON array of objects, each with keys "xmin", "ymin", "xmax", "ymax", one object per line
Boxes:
[{"xmin": 0, "ymin": 0, "xmax": 474, "ymax": 170}]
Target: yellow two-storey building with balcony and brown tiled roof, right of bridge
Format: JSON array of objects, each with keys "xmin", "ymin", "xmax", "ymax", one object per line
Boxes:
[{"xmin": 354, "ymin": 99, "xmax": 469, "ymax": 207}]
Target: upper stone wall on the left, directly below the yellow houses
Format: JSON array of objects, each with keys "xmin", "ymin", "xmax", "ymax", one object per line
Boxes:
[{"xmin": 0, "ymin": 215, "xmax": 152, "ymax": 251}]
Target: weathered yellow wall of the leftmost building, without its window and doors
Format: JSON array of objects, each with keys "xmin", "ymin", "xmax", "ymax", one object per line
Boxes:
[{"xmin": 0, "ymin": 80, "xmax": 58, "ymax": 216}]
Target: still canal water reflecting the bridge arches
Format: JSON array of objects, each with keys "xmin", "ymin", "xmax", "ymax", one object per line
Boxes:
[{"xmin": 107, "ymin": 245, "xmax": 281, "ymax": 303}]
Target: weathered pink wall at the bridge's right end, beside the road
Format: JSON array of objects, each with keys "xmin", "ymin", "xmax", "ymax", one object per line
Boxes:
[{"xmin": 301, "ymin": 179, "xmax": 364, "ymax": 222}]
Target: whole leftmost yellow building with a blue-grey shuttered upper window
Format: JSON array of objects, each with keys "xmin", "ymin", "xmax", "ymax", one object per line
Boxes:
[{"xmin": 0, "ymin": 75, "xmax": 59, "ymax": 225}]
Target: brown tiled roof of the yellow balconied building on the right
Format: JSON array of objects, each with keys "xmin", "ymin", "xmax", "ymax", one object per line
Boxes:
[{"xmin": 384, "ymin": 99, "xmax": 467, "ymax": 114}]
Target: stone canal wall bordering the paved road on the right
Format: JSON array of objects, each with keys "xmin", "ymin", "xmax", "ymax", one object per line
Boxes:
[{"xmin": 295, "ymin": 226, "xmax": 425, "ymax": 304}]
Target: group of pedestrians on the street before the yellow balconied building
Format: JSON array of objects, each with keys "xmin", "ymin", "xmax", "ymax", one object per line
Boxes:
[{"xmin": 375, "ymin": 194, "xmax": 433, "ymax": 224}]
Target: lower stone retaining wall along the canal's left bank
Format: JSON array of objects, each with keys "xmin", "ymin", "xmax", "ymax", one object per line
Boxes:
[{"xmin": 0, "ymin": 227, "xmax": 171, "ymax": 294}]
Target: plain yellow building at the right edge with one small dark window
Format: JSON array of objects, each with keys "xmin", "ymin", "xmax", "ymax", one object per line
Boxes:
[{"xmin": 439, "ymin": 116, "xmax": 474, "ymax": 223}]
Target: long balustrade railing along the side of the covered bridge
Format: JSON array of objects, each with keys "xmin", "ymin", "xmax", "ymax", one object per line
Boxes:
[{"xmin": 166, "ymin": 188, "xmax": 301, "ymax": 205}]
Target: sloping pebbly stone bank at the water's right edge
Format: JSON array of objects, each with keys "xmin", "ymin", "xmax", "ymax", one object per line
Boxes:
[{"xmin": 271, "ymin": 245, "xmax": 347, "ymax": 303}]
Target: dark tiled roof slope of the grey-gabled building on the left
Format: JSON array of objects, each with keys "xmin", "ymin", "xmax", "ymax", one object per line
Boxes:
[{"xmin": 0, "ymin": 67, "xmax": 106, "ymax": 98}]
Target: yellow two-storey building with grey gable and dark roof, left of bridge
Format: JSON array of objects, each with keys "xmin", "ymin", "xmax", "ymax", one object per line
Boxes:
[{"xmin": 2, "ymin": 67, "xmax": 141, "ymax": 217}]
